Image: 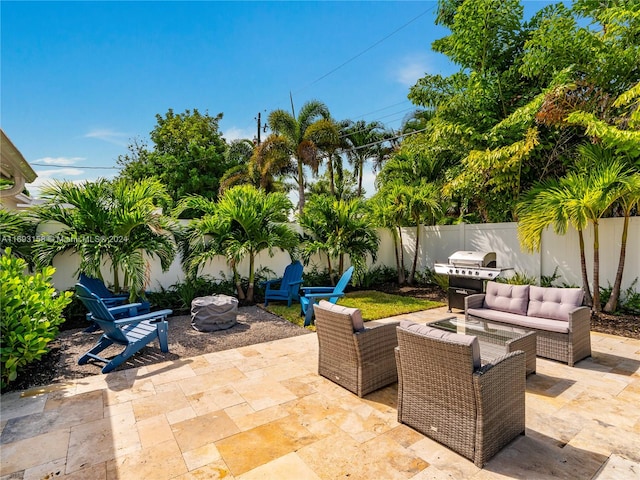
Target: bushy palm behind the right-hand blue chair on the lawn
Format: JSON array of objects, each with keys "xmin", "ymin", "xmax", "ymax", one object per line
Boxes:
[{"xmin": 298, "ymin": 195, "xmax": 379, "ymax": 284}]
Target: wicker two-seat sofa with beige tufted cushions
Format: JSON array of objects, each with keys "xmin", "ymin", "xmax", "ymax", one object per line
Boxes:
[{"xmin": 464, "ymin": 282, "xmax": 591, "ymax": 366}]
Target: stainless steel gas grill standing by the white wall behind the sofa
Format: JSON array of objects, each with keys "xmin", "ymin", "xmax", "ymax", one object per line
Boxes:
[{"xmin": 433, "ymin": 250, "xmax": 510, "ymax": 311}]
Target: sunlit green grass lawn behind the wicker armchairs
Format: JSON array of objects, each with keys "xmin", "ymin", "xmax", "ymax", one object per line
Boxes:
[{"xmin": 266, "ymin": 290, "xmax": 444, "ymax": 330}]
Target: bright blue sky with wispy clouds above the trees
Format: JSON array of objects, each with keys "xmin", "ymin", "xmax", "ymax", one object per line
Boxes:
[{"xmin": 0, "ymin": 0, "xmax": 546, "ymax": 197}]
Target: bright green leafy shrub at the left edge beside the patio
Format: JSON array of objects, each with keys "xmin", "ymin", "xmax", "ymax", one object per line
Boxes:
[{"xmin": 0, "ymin": 248, "xmax": 71, "ymax": 387}]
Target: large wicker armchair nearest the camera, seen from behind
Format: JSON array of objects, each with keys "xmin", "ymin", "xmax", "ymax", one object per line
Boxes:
[{"xmin": 395, "ymin": 324, "xmax": 525, "ymax": 468}]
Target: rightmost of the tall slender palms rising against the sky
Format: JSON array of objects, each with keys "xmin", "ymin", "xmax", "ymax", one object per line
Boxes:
[{"xmin": 341, "ymin": 120, "xmax": 387, "ymax": 197}]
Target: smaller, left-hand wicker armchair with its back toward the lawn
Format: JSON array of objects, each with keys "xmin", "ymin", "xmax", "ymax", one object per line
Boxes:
[{"xmin": 313, "ymin": 301, "xmax": 398, "ymax": 397}]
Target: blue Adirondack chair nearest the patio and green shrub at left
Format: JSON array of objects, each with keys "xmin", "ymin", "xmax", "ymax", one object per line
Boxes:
[{"xmin": 76, "ymin": 283, "xmax": 173, "ymax": 373}]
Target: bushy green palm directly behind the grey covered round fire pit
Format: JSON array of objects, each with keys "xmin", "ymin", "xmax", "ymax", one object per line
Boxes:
[{"xmin": 183, "ymin": 185, "xmax": 298, "ymax": 302}]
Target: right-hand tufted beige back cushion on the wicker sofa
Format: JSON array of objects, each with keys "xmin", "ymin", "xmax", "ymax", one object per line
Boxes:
[{"xmin": 527, "ymin": 285, "xmax": 584, "ymax": 322}]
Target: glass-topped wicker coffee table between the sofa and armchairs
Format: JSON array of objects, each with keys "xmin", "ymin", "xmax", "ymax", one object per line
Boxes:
[{"xmin": 427, "ymin": 317, "xmax": 536, "ymax": 375}]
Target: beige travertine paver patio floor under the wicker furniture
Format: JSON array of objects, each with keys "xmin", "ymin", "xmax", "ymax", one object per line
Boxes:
[{"xmin": 0, "ymin": 309, "xmax": 640, "ymax": 480}]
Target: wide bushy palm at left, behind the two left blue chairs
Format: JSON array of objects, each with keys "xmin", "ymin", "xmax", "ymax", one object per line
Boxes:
[{"xmin": 33, "ymin": 179, "xmax": 176, "ymax": 299}]
